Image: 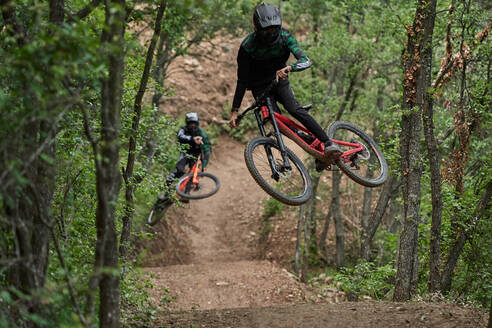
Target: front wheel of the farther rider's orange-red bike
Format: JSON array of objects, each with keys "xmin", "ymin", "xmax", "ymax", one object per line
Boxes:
[{"xmin": 176, "ymin": 172, "xmax": 220, "ymax": 199}]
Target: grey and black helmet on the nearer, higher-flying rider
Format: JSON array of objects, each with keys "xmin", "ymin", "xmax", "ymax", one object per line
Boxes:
[{"xmin": 253, "ymin": 3, "xmax": 282, "ymax": 44}]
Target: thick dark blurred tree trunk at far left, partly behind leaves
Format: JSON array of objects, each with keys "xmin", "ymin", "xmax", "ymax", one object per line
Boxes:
[{"xmin": 0, "ymin": 0, "xmax": 63, "ymax": 313}]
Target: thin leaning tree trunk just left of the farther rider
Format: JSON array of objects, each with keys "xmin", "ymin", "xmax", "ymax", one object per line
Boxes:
[{"xmin": 120, "ymin": 0, "xmax": 167, "ymax": 258}]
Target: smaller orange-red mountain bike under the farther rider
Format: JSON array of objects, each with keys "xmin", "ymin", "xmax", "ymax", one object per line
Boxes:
[{"xmin": 147, "ymin": 149, "xmax": 220, "ymax": 225}]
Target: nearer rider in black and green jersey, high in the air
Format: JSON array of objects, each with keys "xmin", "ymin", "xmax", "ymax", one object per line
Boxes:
[{"xmin": 229, "ymin": 3, "xmax": 341, "ymax": 170}]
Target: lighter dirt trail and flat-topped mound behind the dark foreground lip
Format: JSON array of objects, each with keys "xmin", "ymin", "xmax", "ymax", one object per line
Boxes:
[{"xmin": 147, "ymin": 137, "xmax": 312, "ymax": 310}]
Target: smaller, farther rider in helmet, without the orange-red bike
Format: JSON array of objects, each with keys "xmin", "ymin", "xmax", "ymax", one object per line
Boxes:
[{"xmin": 158, "ymin": 112, "xmax": 211, "ymax": 204}]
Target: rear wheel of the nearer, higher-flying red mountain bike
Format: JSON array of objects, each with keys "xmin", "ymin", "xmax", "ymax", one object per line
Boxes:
[{"xmin": 327, "ymin": 121, "xmax": 389, "ymax": 187}]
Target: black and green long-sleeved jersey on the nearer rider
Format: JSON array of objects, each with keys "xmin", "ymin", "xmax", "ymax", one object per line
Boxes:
[{"xmin": 232, "ymin": 29, "xmax": 311, "ymax": 109}]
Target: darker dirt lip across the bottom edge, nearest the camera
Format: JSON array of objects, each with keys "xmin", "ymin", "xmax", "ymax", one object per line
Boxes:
[{"xmin": 156, "ymin": 302, "xmax": 486, "ymax": 328}]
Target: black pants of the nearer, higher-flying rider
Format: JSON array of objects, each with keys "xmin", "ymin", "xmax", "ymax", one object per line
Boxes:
[{"xmin": 252, "ymin": 79, "xmax": 330, "ymax": 143}]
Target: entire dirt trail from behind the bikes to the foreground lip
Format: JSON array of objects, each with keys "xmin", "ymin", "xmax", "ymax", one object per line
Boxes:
[{"xmin": 141, "ymin": 137, "xmax": 487, "ymax": 328}]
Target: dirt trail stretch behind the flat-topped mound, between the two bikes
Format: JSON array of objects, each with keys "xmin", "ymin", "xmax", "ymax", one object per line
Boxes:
[{"xmin": 178, "ymin": 137, "xmax": 264, "ymax": 264}]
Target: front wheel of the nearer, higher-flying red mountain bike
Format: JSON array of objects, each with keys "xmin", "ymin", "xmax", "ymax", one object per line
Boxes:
[{"xmin": 244, "ymin": 137, "xmax": 312, "ymax": 205}]
